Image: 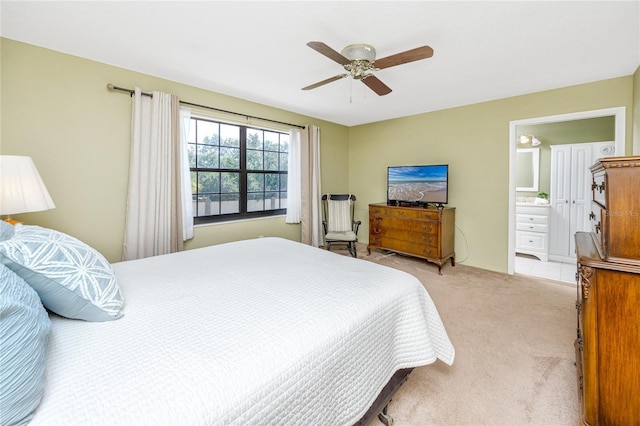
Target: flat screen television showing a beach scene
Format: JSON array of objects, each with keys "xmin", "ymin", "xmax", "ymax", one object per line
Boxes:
[{"xmin": 387, "ymin": 164, "xmax": 449, "ymax": 207}]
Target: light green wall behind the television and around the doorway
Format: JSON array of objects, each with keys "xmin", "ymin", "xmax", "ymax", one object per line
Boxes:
[{"xmin": 349, "ymin": 76, "xmax": 633, "ymax": 272}]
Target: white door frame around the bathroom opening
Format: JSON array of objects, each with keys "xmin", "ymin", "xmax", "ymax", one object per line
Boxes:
[{"xmin": 507, "ymin": 107, "xmax": 627, "ymax": 275}]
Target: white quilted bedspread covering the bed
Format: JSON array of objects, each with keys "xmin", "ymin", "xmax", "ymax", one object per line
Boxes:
[{"xmin": 31, "ymin": 238, "xmax": 454, "ymax": 426}]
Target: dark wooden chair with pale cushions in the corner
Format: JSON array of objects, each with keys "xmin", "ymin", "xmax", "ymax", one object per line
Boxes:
[{"xmin": 322, "ymin": 194, "xmax": 361, "ymax": 257}]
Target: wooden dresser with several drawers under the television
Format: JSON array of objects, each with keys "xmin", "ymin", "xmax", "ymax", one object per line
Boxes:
[{"xmin": 367, "ymin": 203, "xmax": 456, "ymax": 274}]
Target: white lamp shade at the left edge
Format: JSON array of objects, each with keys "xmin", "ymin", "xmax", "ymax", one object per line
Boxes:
[{"xmin": 0, "ymin": 155, "xmax": 56, "ymax": 215}]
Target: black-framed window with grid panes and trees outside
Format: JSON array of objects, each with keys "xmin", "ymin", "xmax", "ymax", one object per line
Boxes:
[{"xmin": 189, "ymin": 117, "xmax": 289, "ymax": 224}]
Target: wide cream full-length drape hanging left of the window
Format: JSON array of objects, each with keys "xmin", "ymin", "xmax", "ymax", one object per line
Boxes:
[{"xmin": 123, "ymin": 87, "xmax": 192, "ymax": 260}]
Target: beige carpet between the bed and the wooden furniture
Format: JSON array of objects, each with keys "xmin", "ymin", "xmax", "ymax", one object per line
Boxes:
[{"xmin": 344, "ymin": 244, "xmax": 579, "ymax": 426}]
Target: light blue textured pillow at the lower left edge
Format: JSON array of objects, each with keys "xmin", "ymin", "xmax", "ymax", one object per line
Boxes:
[{"xmin": 0, "ymin": 264, "xmax": 51, "ymax": 425}]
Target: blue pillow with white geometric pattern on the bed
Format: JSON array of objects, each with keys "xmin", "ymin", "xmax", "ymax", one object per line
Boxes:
[{"xmin": 0, "ymin": 224, "xmax": 124, "ymax": 321}]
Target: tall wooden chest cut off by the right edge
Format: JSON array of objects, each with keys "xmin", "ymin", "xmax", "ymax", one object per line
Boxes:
[{"xmin": 575, "ymin": 157, "xmax": 640, "ymax": 425}]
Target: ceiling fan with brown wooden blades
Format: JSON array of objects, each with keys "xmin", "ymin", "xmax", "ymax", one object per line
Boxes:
[{"xmin": 302, "ymin": 41, "xmax": 433, "ymax": 96}]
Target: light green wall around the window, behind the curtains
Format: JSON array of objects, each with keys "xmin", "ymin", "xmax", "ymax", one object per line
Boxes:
[{"xmin": 0, "ymin": 38, "xmax": 349, "ymax": 262}]
